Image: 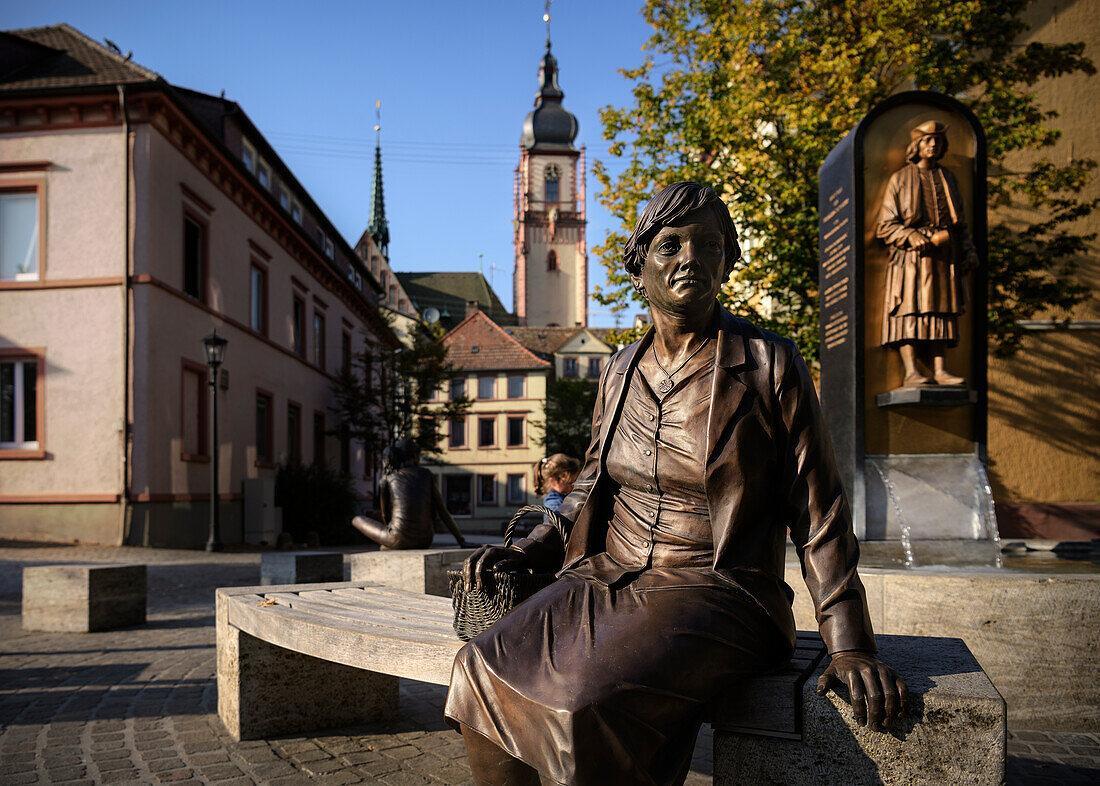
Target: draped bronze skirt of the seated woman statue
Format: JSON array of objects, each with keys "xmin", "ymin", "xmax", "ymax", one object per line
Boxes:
[{"xmin": 446, "ymin": 569, "xmax": 790, "ymax": 786}]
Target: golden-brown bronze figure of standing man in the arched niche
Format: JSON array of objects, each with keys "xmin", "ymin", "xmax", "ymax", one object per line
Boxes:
[{"xmin": 877, "ymin": 120, "xmax": 978, "ymax": 387}]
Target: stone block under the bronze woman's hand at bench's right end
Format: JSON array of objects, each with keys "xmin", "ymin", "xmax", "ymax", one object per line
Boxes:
[{"xmin": 714, "ymin": 635, "xmax": 1007, "ymax": 786}]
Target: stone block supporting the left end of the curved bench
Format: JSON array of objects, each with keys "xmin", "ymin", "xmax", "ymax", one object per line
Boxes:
[{"xmin": 216, "ymin": 593, "xmax": 399, "ymax": 740}]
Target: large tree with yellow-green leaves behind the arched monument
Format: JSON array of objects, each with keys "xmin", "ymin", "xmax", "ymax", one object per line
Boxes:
[{"xmin": 594, "ymin": 0, "xmax": 1097, "ymax": 359}]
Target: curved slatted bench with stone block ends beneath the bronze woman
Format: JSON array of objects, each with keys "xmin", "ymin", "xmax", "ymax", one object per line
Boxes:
[{"xmin": 217, "ymin": 582, "xmax": 1005, "ymax": 784}]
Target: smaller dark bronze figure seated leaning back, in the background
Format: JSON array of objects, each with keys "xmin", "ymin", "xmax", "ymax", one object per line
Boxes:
[{"xmin": 351, "ymin": 440, "xmax": 466, "ymax": 550}]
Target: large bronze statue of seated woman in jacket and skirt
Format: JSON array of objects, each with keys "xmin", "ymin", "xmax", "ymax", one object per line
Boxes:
[{"xmin": 446, "ymin": 182, "xmax": 906, "ymax": 784}]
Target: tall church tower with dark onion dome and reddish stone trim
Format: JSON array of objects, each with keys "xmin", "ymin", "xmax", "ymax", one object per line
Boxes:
[{"xmin": 513, "ymin": 23, "xmax": 589, "ymax": 328}]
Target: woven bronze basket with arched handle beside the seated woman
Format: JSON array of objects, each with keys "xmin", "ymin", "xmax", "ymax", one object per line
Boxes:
[{"xmin": 447, "ymin": 505, "xmax": 564, "ymax": 641}]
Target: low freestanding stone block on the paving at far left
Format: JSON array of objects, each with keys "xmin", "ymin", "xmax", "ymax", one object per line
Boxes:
[{"xmin": 23, "ymin": 565, "xmax": 146, "ymax": 633}]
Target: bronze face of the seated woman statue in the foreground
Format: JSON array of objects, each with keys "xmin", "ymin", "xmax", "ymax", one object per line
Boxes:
[{"xmin": 630, "ymin": 208, "xmax": 729, "ymax": 314}]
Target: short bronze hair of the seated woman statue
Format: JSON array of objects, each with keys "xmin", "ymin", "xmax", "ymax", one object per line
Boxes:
[{"xmin": 623, "ymin": 182, "xmax": 741, "ymax": 276}]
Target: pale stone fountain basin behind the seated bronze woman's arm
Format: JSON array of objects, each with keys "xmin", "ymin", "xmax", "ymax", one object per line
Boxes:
[{"xmin": 785, "ymin": 543, "xmax": 1100, "ymax": 731}]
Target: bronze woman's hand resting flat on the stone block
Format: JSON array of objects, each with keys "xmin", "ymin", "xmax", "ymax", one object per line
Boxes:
[{"xmin": 817, "ymin": 652, "xmax": 909, "ymax": 731}]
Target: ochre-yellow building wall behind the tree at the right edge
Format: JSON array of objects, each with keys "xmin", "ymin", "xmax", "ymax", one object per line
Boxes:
[{"xmin": 989, "ymin": 0, "xmax": 1100, "ymax": 502}]
